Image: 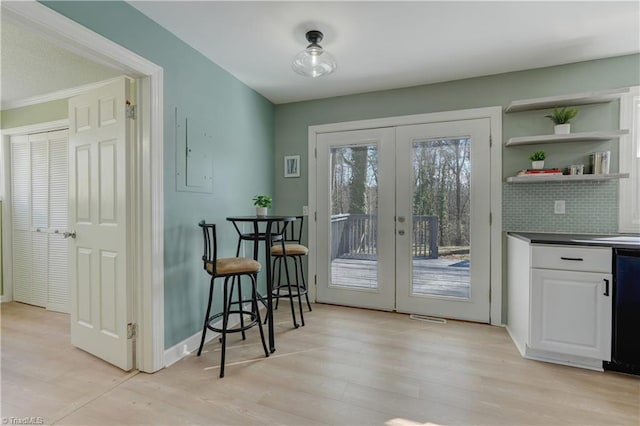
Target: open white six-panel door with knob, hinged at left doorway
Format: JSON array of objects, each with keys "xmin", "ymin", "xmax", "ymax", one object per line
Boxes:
[{"xmin": 69, "ymin": 77, "xmax": 134, "ymax": 370}]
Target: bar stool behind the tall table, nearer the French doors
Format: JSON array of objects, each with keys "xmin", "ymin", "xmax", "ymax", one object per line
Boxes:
[{"xmin": 271, "ymin": 216, "xmax": 312, "ymax": 328}]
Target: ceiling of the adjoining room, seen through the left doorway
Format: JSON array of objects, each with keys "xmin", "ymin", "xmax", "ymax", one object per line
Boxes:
[{"xmin": 0, "ymin": 17, "xmax": 121, "ymax": 109}]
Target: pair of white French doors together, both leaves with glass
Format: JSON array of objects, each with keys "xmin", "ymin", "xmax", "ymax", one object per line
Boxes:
[{"xmin": 316, "ymin": 119, "xmax": 490, "ymax": 322}]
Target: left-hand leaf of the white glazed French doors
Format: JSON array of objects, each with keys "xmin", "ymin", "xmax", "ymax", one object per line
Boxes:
[{"xmin": 316, "ymin": 128, "xmax": 395, "ymax": 310}]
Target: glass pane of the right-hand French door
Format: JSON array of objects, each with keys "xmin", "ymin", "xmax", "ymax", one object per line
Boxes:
[{"xmin": 411, "ymin": 137, "xmax": 471, "ymax": 299}]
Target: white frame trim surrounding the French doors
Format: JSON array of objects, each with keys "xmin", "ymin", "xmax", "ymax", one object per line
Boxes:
[{"xmin": 307, "ymin": 106, "xmax": 502, "ymax": 325}]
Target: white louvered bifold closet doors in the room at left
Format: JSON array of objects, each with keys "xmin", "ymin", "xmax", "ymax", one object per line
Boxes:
[{"xmin": 11, "ymin": 130, "xmax": 69, "ymax": 312}]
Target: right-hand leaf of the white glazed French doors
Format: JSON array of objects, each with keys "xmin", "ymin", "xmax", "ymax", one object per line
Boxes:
[{"xmin": 396, "ymin": 119, "xmax": 490, "ymax": 323}]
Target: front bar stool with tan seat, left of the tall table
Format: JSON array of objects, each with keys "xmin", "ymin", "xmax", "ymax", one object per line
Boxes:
[{"xmin": 198, "ymin": 221, "xmax": 269, "ymax": 377}]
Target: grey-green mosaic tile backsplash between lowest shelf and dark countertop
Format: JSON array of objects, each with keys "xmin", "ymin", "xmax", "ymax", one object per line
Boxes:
[{"xmin": 502, "ymin": 180, "xmax": 618, "ymax": 234}]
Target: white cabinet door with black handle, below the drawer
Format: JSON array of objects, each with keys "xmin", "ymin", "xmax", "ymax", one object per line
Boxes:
[{"xmin": 531, "ymin": 268, "xmax": 612, "ymax": 361}]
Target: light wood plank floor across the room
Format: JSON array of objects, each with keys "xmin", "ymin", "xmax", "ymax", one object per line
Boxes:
[{"xmin": 1, "ymin": 303, "xmax": 640, "ymax": 426}]
